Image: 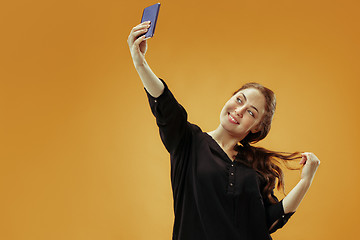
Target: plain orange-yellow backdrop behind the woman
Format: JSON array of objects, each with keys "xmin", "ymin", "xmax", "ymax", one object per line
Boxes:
[{"xmin": 0, "ymin": 0, "xmax": 360, "ymax": 240}]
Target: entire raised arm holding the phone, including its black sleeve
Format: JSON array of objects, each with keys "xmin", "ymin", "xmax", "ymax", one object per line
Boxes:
[{"xmin": 128, "ymin": 22, "xmax": 191, "ymax": 156}]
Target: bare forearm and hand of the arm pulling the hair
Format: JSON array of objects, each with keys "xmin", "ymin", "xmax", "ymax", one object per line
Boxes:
[{"xmin": 283, "ymin": 152, "xmax": 320, "ymax": 213}]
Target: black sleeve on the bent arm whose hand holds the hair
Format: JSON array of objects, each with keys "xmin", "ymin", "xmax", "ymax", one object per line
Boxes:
[{"xmin": 265, "ymin": 192, "xmax": 295, "ymax": 233}]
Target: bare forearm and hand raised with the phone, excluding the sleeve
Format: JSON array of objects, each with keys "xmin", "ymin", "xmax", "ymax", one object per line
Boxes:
[{"xmin": 127, "ymin": 22, "xmax": 164, "ymax": 98}]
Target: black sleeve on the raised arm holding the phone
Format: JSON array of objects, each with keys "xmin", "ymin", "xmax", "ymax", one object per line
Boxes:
[{"xmin": 145, "ymin": 79, "xmax": 190, "ymax": 155}]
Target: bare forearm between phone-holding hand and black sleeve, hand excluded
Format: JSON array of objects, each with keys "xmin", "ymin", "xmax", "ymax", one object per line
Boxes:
[{"xmin": 135, "ymin": 61, "xmax": 165, "ymax": 97}]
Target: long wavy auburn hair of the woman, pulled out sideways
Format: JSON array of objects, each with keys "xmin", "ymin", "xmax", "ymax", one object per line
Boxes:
[{"xmin": 233, "ymin": 82, "xmax": 301, "ymax": 203}]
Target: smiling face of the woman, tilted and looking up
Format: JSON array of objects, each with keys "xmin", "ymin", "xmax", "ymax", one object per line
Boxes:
[{"xmin": 220, "ymin": 88, "xmax": 265, "ymax": 140}]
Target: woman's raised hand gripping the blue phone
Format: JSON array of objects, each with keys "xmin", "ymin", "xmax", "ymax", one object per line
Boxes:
[{"xmin": 127, "ymin": 21, "xmax": 150, "ymax": 67}]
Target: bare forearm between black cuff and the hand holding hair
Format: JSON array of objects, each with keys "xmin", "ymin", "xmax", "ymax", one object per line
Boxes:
[{"xmin": 283, "ymin": 179, "xmax": 311, "ymax": 214}]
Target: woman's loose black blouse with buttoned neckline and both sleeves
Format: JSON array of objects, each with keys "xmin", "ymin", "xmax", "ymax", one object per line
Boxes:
[{"xmin": 147, "ymin": 79, "xmax": 293, "ymax": 240}]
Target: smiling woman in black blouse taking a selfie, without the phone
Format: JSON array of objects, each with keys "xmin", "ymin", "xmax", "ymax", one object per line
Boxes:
[{"xmin": 128, "ymin": 22, "xmax": 320, "ymax": 240}]
